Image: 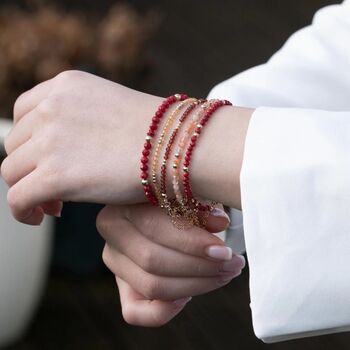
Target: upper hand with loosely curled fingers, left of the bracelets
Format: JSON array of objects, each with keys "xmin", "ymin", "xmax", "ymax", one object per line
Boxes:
[{"xmin": 1, "ymin": 71, "xmax": 163, "ymax": 225}]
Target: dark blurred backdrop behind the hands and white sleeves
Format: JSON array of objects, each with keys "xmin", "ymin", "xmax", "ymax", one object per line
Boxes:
[{"xmin": 0, "ymin": 0, "xmax": 350, "ymax": 350}]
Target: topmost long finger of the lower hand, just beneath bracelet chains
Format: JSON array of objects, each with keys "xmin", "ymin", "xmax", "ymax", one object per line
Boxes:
[{"xmin": 121, "ymin": 203, "xmax": 232, "ymax": 260}]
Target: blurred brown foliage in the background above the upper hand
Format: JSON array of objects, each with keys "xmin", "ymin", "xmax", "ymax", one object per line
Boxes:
[{"xmin": 0, "ymin": 0, "xmax": 159, "ymax": 117}]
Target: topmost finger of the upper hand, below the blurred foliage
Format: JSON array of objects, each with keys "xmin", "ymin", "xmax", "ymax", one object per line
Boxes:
[{"xmin": 13, "ymin": 79, "xmax": 53, "ymax": 124}]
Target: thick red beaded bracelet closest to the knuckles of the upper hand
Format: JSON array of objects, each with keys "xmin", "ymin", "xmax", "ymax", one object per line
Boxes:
[{"xmin": 140, "ymin": 94, "xmax": 188, "ymax": 206}]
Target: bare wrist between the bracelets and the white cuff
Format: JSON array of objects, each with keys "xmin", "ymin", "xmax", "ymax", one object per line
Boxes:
[{"xmin": 167, "ymin": 102, "xmax": 254, "ymax": 209}]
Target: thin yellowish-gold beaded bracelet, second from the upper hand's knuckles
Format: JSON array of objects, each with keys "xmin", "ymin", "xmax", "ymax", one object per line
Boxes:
[{"xmin": 152, "ymin": 98, "xmax": 197, "ymax": 208}]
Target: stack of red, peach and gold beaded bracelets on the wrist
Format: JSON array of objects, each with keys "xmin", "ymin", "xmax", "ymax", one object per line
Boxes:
[{"xmin": 140, "ymin": 94, "xmax": 232, "ymax": 229}]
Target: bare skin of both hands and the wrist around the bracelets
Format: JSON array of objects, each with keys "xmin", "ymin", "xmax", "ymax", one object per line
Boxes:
[{"xmin": 0, "ymin": 71, "xmax": 253, "ymax": 326}]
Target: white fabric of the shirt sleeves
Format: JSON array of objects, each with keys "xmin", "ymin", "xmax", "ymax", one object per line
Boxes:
[{"xmin": 208, "ymin": 0, "xmax": 350, "ymax": 343}]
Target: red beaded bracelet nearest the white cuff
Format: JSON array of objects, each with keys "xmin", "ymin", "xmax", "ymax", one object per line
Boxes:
[{"xmin": 182, "ymin": 100, "xmax": 232, "ymax": 210}]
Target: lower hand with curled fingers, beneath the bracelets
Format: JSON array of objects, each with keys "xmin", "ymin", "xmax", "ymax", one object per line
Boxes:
[{"xmin": 96, "ymin": 204, "xmax": 245, "ymax": 327}]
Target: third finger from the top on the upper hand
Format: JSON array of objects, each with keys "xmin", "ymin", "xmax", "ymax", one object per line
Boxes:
[{"xmin": 1, "ymin": 139, "xmax": 38, "ymax": 187}]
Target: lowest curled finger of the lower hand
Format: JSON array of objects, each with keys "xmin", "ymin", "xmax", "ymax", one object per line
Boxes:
[{"xmin": 116, "ymin": 277, "xmax": 191, "ymax": 327}]
